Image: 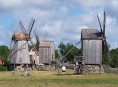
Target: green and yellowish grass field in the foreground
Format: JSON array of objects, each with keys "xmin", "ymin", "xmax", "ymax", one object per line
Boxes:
[{"xmin": 0, "ymin": 70, "xmax": 118, "ymax": 87}]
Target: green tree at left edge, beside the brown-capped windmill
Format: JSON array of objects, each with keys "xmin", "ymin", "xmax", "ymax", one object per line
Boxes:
[{"xmin": 0, "ymin": 45, "xmax": 10, "ymax": 62}]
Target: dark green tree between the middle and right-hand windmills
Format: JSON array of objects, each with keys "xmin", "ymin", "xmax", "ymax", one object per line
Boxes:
[{"xmin": 58, "ymin": 42, "xmax": 81, "ymax": 62}]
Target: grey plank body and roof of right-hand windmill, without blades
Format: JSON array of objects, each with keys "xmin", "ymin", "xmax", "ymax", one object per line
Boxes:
[{"xmin": 81, "ymin": 29, "xmax": 102, "ymax": 65}]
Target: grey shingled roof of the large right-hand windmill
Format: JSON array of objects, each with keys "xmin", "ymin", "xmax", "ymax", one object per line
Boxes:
[{"xmin": 81, "ymin": 29, "xmax": 102, "ymax": 40}]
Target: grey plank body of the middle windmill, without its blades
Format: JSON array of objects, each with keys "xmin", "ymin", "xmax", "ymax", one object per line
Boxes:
[{"xmin": 39, "ymin": 41, "xmax": 55, "ymax": 64}]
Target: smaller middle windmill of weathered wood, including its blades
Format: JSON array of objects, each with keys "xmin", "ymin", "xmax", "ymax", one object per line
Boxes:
[{"xmin": 35, "ymin": 32, "xmax": 55, "ymax": 64}]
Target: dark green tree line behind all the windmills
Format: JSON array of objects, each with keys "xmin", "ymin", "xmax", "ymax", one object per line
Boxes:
[{"xmin": 0, "ymin": 42, "xmax": 118, "ymax": 67}]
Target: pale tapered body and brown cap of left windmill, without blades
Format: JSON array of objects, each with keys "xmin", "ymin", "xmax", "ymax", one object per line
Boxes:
[{"xmin": 10, "ymin": 33, "xmax": 30, "ymax": 64}]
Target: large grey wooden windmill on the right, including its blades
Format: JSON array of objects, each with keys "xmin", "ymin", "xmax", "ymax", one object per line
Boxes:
[{"xmin": 81, "ymin": 12, "xmax": 108, "ymax": 73}]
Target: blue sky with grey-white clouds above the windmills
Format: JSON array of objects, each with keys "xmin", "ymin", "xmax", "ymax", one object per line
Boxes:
[{"xmin": 0, "ymin": 0, "xmax": 118, "ymax": 48}]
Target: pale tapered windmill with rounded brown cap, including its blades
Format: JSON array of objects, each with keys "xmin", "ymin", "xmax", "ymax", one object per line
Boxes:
[{"xmin": 8, "ymin": 18, "xmax": 35, "ymax": 70}]
